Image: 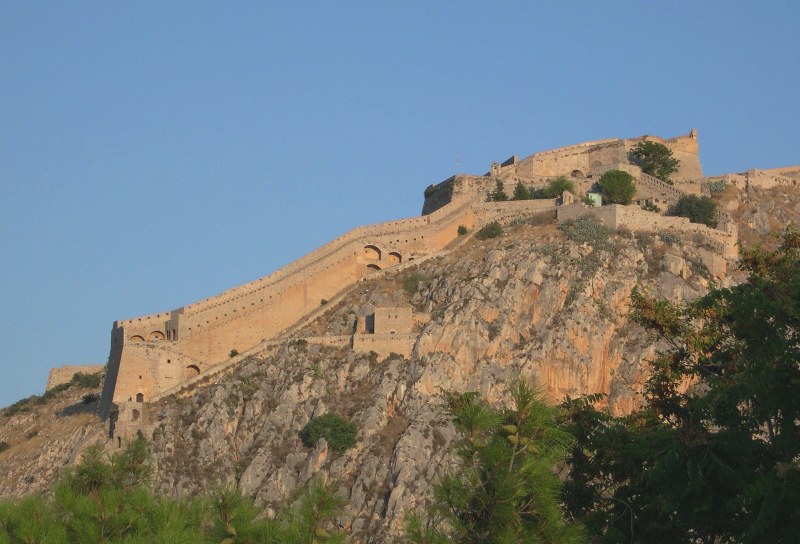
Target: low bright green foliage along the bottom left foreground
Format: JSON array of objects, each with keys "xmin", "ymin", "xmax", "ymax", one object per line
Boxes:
[{"xmin": 0, "ymin": 438, "xmax": 345, "ymax": 544}]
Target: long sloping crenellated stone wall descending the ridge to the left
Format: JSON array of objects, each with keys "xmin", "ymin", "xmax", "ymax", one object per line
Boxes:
[{"xmin": 100, "ymin": 193, "xmax": 475, "ymax": 417}]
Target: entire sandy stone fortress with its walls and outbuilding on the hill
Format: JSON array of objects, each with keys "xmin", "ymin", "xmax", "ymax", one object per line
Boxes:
[{"xmin": 100, "ymin": 130, "xmax": 794, "ymax": 436}]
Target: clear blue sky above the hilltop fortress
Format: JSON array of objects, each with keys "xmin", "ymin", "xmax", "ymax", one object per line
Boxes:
[{"xmin": 0, "ymin": 0, "xmax": 800, "ymax": 405}]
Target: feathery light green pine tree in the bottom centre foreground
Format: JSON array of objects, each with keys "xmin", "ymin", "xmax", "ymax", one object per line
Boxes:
[{"xmin": 406, "ymin": 381, "xmax": 585, "ymax": 544}]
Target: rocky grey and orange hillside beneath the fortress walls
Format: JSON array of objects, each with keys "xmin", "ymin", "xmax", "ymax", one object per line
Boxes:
[{"xmin": 0, "ymin": 173, "xmax": 800, "ymax": 542}]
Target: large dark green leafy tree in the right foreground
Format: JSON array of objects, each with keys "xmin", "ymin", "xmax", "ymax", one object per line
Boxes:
[{"xmin": 565, "ymin": 227, "xmax": 800, "ymax": 544}]
